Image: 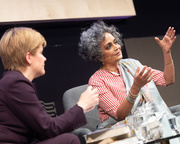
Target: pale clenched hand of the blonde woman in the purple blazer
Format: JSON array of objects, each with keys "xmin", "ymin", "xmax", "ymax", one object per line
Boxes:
[{"xmin": 77, "ymin": 86, "xmax": 99, "ymax": 112}]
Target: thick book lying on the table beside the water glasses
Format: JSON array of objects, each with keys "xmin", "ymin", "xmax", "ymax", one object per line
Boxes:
[{"xmin": 85, "ymin": 125, "xmax": 131, "ymax": 144}]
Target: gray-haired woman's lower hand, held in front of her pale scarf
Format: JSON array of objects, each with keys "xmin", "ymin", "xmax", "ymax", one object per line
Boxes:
[{"xmin": 132, "ymin": 66, "xmax": 152, "ymax": 93}]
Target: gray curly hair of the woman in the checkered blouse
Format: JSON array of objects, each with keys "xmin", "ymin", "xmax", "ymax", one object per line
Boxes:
[{"xmin": 79, "ymin": 21, "xmax": 123, "ymax": 62}]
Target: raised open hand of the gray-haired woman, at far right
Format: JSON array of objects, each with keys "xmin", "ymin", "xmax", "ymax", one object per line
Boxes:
[{"xmin": 155, "ymin": 27, "xmax": 176, "ymax": 52}]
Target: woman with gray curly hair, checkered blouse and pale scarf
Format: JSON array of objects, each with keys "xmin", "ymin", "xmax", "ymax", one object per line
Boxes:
[{"xmin": 79, "ymin": 21, "xmax": 176, "ymax": 134}]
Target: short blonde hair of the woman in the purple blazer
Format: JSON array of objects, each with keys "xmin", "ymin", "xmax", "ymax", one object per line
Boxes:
[{"xmin": 0, "ymin": 27, "xmax": 46, "ymax": 70}]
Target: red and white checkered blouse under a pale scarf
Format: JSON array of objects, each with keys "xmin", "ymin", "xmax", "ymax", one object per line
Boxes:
[{"xmin": 89, "ymin": 65, "xmax": 166, "ymax": 122}]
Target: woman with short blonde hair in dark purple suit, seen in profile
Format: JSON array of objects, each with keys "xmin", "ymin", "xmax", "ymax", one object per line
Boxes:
[{"xmin": 0, "ymin": 27, "xmax": 98, "ymax": 144}]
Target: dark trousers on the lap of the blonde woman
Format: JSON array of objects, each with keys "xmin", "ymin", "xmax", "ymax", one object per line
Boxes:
[{"xmin": 34, "ymin": 133, "xmax": 81, "ymax": 144}]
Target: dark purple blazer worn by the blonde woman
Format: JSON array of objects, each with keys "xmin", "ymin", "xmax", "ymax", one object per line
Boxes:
[{"xmin": 0, "ymin": 71, "xmax": 86, "ymax": 143}]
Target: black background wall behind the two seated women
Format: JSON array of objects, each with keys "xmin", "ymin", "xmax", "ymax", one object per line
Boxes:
[{"xmin": 0, "ymin": 0, "xmax": 180, "ymax": 114}]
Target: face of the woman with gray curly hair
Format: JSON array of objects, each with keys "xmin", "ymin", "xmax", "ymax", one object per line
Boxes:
[{"xmin": 101, "ymin": 32, "xmax": 123, "ymax": 64}]
